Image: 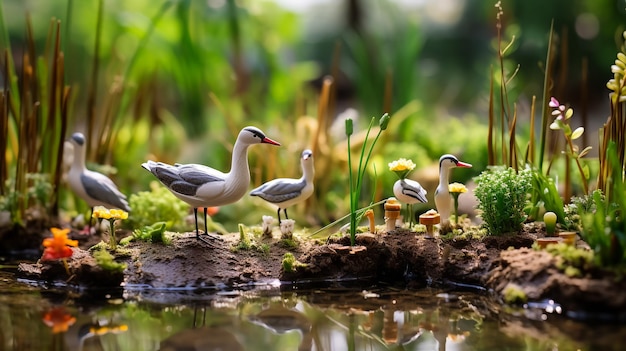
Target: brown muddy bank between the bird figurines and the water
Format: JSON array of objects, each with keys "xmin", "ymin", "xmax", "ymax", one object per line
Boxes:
[{"xmin": 13, "ymin": 226, "xmax": 626, "ymax": 321}]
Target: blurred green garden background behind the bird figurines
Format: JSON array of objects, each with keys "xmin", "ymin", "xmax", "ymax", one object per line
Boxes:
[{"xmin": 0, "ymin": 0, "xmax": 626, "ymax": 231}]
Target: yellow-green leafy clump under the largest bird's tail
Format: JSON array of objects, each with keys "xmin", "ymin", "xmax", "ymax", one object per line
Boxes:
[{"xmin": 128, "ymin": 182, "xmax": 189, "ymax": 231}]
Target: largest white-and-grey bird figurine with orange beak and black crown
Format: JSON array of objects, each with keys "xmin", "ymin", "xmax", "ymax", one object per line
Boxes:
[{"xmin": 141, "ymin": 126, "xmax": 280, "ymax": 244}]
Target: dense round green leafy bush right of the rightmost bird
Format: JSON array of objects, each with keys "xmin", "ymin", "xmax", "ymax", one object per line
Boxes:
[{"xmin": 474, "ymin": 167, "xmax": 532, "ymax": 235}]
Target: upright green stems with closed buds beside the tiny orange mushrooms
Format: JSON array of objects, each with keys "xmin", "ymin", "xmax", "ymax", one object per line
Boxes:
[{"xmin": 346, "ymin": 113, "xmax": 391, "ymax": 246}]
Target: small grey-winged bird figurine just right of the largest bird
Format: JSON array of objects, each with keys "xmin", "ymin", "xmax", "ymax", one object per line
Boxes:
[{"xmin": 250, "ymin": 149, "xmax": 315, "ymax": 225}]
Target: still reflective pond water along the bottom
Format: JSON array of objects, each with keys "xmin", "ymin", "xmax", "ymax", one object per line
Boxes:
[{"xmin": 0, "ymin": 269, "xmax": 626, "ymax": 351}]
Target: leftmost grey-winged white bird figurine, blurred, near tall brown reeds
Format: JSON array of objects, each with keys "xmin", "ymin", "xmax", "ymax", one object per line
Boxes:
[{"xmin": 67, "ymin": 133, "xmax": 130, "ymax": 230}]
